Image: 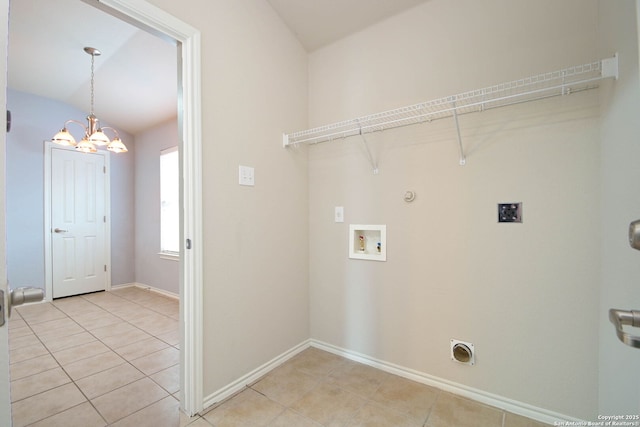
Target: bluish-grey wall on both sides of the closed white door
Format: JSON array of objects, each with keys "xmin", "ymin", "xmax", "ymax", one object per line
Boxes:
[{"xmin": 6, "ymin": 90, "xmax": 135, "ymax": 294}]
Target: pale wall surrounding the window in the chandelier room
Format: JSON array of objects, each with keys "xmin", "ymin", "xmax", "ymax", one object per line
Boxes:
[{"xmin": 133, "ymin": 119, "xmax": 180, "ymax": 295}]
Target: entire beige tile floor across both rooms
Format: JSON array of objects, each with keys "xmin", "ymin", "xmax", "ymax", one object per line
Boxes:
[{"xmin": 10, "ymin": 288, "xmax": 545, "ymax": 427}]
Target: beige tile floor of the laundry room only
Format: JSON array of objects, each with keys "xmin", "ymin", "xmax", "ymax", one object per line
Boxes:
[{"xmin": 200, "ymin": 347, "xmax": 545, "ymax": 427}]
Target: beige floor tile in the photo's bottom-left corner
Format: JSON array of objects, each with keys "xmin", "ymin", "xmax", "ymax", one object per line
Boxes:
[{"xmin": 11, "ymin": 384, "xmax": 86, "ymax": 427}]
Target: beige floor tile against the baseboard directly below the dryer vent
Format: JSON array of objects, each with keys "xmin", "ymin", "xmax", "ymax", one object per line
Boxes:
[{"xmin": 425, "ymin": 392, "xmax": 502, "ymax": 427}]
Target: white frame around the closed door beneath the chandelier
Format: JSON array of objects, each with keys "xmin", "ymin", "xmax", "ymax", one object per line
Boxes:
[{"xmin": 44, "ymin": 141, "xmax": 111, "ymax": 302}]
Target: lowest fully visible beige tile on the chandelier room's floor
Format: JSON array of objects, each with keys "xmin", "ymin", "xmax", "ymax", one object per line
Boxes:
[{"xmin": 92, "ymin": 378, "xmax": 168, "ymax": 423}]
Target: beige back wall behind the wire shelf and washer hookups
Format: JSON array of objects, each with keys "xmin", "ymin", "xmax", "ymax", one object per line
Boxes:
[{"xmin": 309, "ymin": 0, "xmax": 601, "ymax": 419}]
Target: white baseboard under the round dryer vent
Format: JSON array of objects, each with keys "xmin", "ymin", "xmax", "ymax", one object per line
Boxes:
[{"xmin": 309, "ymin": 339, "xmax": 586, "ymax": 425}]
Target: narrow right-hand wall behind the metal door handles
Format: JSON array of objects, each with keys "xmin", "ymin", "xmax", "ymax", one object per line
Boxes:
[{"xmin": 598, "ymin": 0, "xmax": 640, "ymax": 414}]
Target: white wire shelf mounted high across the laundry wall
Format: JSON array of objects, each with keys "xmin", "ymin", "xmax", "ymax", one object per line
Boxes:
[{"xmin": 283, "ymin": 54, "xmax": 618, "ymax": 168}]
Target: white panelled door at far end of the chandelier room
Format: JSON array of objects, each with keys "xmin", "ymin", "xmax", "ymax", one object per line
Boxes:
[{"xmin": 51, "ymin": 148, "xmax": 107, "ymax": 298}]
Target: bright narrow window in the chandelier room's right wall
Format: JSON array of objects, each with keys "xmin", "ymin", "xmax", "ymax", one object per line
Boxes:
[{"xmin": 160, "ymin": 147, "xmax": 180, "ymax": 258}]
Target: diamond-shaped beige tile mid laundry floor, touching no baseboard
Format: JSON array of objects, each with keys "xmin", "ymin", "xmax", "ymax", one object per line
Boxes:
[{"xmin": 290, "ymin": 383, "xmax": 366, "ymax": 426}]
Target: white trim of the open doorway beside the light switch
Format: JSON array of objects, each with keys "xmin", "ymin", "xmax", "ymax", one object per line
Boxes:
[{"xmin": 90, "ymin": 0, "xmax": 204, "ymax": 415}]
